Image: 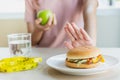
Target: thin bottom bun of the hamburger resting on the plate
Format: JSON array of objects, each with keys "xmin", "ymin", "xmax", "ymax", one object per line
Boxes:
[{"xmin": 65, "ymin": 61, "xmax": 101, "ymax": 69}]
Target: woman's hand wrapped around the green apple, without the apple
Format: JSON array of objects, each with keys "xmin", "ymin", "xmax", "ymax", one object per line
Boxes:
[{"xmin": 35, "ymin": 14, "xmax": 57, "ymax": 31}]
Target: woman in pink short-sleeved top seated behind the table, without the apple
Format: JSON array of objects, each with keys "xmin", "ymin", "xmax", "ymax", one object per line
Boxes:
[{"xmin": 25, "ymin": 0, "xmax": 98, "ymax": 49}]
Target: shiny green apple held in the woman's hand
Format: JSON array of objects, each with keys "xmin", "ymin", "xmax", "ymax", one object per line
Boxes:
[{"xmin": 37, "ymin": 10, "xmax": 53, "ymax": 25}]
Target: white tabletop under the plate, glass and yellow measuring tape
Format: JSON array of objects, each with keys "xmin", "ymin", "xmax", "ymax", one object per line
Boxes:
[{"xmin": 0, "ymin": 47, "xmax": 120, "ymax": 80}]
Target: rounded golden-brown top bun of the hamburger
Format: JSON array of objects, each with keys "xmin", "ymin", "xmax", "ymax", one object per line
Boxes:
[{"xmin": 67, "ymin": 46, "xmax": 101, "ymax": 59}]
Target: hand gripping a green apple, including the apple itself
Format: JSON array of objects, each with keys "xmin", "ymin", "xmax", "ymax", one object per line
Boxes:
[{"xmin": 35, "ymin": 10, "xmax": 57, "ymax": 30}]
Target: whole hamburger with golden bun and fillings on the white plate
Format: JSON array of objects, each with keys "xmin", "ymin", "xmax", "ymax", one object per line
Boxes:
[{"xmin": 65, "ymin": 46, "xmax": 105, "ymax": 69}]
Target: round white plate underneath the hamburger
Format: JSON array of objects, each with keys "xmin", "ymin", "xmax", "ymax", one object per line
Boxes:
[{"xmin": 46, "ymin": 54, "xmax": 119, "ymax": 75}]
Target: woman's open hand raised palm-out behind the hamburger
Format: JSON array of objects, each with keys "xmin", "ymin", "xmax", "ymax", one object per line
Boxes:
[{"xmin": 65, "ymin": 23, "xmax": 95, "ymax": 49}]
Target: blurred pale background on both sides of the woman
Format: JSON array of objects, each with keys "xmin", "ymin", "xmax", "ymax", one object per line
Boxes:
[{"xmin": 0, "ymin": 0, "xmax": 120, "ymax": 47}]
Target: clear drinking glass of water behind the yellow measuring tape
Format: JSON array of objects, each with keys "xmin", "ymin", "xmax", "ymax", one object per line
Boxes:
[{"xmin": 8, "ymin": 33, "xmax": 31, "ymax": 56}]
